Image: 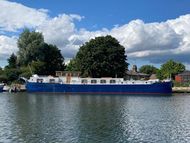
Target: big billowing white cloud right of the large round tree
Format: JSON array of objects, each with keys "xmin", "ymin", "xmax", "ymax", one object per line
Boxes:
[{"xmin": 110, "ymin": 14, "xmax": 190, "ymax": 63}]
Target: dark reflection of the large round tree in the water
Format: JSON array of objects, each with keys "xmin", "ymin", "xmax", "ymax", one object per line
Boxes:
[{"xmin": 74, "ymin": 96, "xmax": 126, "ymax": 142}]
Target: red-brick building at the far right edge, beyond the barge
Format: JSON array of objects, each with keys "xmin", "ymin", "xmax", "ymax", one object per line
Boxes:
[{"xmin": 175, "ymin": 71, "xmax": 190, "ymax": 83}]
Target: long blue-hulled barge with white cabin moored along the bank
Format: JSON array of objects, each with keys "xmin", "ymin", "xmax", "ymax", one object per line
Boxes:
[{"xmin": 26, "ymin": 74, "xmax": 172, "ymax": 94}]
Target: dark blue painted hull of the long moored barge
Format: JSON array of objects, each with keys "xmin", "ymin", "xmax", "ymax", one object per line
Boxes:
[{"xmin": 26, "ymin": 82, "xmax": 172, "ymax": 94}]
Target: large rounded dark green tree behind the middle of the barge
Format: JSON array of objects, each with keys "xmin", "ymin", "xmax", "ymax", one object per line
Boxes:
[{"xmin": 75, "ymin": 36, "xmax": 128, "ymax": 77}]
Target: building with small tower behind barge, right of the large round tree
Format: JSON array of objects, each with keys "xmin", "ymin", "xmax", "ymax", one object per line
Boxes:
[{"xmin": 125, "ymin": 65, "xmax": 150, "ymax": 80}]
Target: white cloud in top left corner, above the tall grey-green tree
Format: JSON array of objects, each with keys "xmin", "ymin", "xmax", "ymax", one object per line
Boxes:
[{"xmin": 0, "ymin": 0, "xmax": 48, "ymax": 32}]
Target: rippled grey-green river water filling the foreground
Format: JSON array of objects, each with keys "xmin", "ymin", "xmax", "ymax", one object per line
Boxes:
[{"xmin": 0, "ymin": 93, "xmax": 190, "ymax": 143}]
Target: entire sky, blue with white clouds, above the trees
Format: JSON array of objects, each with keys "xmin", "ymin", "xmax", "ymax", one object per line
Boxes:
[{"xmin": 0, "ymin": 0, "xmax": 190, "ymax": 69}]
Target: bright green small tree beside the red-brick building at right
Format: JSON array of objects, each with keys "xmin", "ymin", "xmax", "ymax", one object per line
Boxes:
[{"xmin": 157, "ymin": 60, "xmax": 185, "ymax": 79}]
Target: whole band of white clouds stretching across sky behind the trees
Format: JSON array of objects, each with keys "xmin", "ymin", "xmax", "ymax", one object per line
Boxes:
[{"xmin": 0, "ymin": 0, "xmax": 190, "ymax": 68}]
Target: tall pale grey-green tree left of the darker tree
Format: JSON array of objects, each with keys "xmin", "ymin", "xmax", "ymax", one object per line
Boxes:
[{"xmin": 17, "ymin": 29, "xmax": 44, "ymax": 66}]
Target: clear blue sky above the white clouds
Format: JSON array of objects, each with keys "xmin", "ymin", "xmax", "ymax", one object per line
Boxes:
[{"xmin": 12, "ymin": 0, "xmax": 190, "ymax": 30}]
